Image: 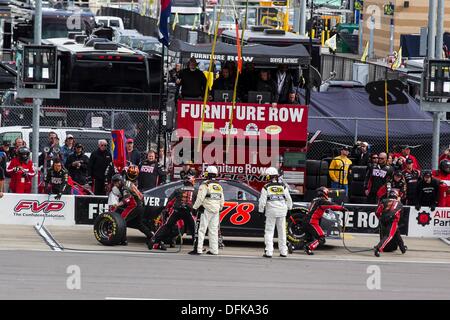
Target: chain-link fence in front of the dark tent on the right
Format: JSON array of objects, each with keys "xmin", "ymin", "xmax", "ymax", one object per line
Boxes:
[{"xmin": 308, "ymin": 117, "xmax": 450, "ymax": 169}]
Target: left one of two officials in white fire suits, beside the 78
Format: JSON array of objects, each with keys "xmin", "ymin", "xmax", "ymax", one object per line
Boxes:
[{"xmin": 193, "ymin": 180, "xmax": 225, "ymax": 254}]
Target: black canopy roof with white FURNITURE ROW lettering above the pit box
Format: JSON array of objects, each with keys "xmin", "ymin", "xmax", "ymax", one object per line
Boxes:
[{"xmin": 169, "ymin": 40, "xmax": 310, "ymax": 66}]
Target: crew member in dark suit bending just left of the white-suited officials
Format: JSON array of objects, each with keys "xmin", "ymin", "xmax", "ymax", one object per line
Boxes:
[{"xmin": 154, "ymin": 184, "xmax": 197, "ymax": 243}]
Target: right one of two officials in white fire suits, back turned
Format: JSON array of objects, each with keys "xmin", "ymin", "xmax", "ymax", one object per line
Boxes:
[{"xmin": 258, "ymin": 181, "xmax": 292, "ymax": 256}]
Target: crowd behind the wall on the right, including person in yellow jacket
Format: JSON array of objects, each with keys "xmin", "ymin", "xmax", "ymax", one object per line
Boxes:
[{"xmin": 329, "ymin": 141, "xmax": 450, "ymax": 210}]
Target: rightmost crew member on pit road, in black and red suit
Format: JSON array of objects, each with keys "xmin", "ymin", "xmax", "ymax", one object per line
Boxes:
[{"xmin": 375, "ymin": 199, "xmax": 406, "ymax": 252}]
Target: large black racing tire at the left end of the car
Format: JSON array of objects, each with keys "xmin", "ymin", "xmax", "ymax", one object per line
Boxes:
[{"xmin": 94, "ymin": 212, "xmax": 127, "ymax": 246}]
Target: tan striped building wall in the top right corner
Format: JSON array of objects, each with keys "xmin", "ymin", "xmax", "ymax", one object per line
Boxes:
[{"xmin": 363, "ymin": 0, "xmax": 450, "ymax": 57}]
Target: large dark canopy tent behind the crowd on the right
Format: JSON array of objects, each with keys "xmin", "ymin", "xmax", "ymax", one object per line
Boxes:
[{"xmin": 302, "ymin": 88, "xmax": 450, "ymax": 167}]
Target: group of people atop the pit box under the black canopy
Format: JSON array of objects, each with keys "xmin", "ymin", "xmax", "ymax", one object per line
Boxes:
[{"xmin": 169, "ymin": 58, "xmax": 300, "ymax": 104}]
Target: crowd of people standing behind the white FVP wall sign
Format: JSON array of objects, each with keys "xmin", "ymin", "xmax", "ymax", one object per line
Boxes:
[{"xmin": 0, "ymin": 132, "xmax": 167, "ymax": 196}]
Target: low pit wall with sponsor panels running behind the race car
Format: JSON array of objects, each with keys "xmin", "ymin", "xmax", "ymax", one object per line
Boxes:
[{"xmin": 0, "ymin": 193, "xmax": 450, "ymax": 238}]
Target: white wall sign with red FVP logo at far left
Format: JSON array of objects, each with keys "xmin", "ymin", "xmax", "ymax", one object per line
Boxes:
[{"xmin": 0, "ymin": 193, "xmax": 75, "ymax": 226}]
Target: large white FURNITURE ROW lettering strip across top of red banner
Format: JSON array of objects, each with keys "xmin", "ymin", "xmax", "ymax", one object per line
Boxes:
[{"xmin": 180, "ymin": 103, "xmax": 305, "ymax": 123}]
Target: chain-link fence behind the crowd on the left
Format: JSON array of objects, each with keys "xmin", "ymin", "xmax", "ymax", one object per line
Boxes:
[{"xmin": 0, "ymin": 106, "xmax": 166, "ymax": 153}]
